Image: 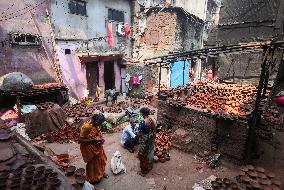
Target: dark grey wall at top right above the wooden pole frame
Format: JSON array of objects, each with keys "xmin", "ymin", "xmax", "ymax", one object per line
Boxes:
[{"xmin": 218, "ymin": 0, "xmax": 284, "ymax": 45}]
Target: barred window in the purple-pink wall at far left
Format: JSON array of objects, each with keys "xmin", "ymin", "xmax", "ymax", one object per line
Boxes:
[{"xmin": 10, "ymin": 33, "xmax": 41, "ymax": 46}]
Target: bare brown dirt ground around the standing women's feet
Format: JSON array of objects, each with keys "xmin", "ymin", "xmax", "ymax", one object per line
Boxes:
[{"xmin": 43, "ymin": 133, "xmax": 238, "ymax": 190}]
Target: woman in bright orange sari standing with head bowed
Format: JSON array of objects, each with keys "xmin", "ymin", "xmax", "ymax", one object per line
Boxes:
[{"xmin": 79, "ymin": 114, "xmax": 107, "ymax": 183}]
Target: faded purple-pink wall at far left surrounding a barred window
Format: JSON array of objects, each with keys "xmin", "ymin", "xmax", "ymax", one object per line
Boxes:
[{"xmin": 0, "ymin": 0, "xmax": 55, "ymax": 83}]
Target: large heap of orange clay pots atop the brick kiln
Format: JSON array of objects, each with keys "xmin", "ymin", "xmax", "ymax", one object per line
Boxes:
[{"xmin": 162, "ymin": 82, "xmax": 279, "ymax": 123}]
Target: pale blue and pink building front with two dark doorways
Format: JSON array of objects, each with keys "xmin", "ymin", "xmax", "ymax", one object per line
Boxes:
[{"xmin": 51, "ymin": 0, "xmax": 131, "ymax": 98}]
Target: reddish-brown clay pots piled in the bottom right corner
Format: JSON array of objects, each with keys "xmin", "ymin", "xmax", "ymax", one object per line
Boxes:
[{"xmin": 239, "ymin": 165, "xmax": 281, "ymax": 190}]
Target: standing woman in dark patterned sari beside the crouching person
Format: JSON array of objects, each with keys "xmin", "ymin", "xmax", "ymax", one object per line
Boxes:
[{"xmin": 138, "ymin": 108, "xmax": 156, "ymax": 176}]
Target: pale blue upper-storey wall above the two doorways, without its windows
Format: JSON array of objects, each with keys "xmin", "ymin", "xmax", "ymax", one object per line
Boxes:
[{"xmin": 51, "ymin": 0, "xmax": 131, "ymax": 54}]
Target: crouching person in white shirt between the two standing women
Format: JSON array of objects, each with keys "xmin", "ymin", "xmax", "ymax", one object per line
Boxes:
[{"xmin": 121, "ymin": 118, "xmax": 138, "ymax": 153}]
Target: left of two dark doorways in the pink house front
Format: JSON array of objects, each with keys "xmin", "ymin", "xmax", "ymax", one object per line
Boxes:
[{"xmin": 86, "ymin": 62, "xmax": 99, "ymax": 96}]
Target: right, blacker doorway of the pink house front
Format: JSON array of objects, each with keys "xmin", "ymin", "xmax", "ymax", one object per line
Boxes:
[{"xmin": 104, "ymin": 61, "xmax": 115, "ymax": 90}]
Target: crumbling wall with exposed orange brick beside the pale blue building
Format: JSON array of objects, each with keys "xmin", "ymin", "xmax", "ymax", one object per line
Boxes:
[{"xmin": 133, "ymin": 8, "xmax": 203, "ymax": 59}]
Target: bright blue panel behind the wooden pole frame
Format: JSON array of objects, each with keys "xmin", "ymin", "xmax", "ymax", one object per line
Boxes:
[{"xmin": 170, "ymin": 60, "xmax": 189, "ymax": 88}]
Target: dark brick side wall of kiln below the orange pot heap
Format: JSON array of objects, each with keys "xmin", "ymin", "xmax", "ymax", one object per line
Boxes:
[{"xmin": 158, "ymin": 101, "xmax": 248, "ymax": 162}]
